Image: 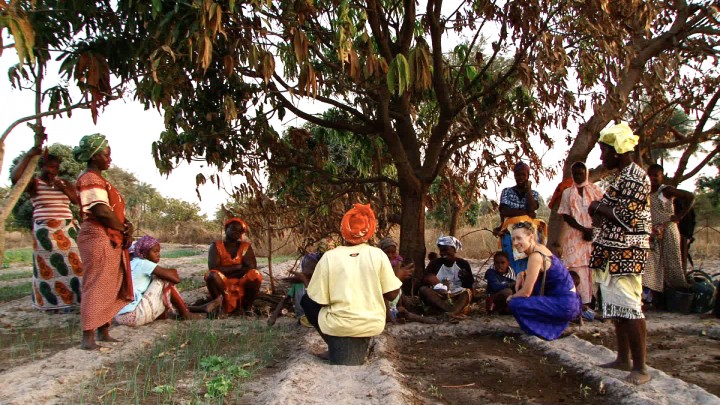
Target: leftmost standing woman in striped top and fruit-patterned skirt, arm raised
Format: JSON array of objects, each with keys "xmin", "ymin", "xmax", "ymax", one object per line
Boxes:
[{"xmin": 11, "ymin": 147, "xmax": 82, "ymax": 310}]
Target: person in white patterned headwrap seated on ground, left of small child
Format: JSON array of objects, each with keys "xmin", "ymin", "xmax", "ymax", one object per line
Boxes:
[{"xmin": 419, "ymin": 236, "xmax": 474, "ymax": 318}]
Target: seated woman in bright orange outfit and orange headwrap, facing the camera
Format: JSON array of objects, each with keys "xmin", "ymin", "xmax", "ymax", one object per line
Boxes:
[{"xmin": 205, "ymin": 218, "xmax": 262, "ymax": 315}]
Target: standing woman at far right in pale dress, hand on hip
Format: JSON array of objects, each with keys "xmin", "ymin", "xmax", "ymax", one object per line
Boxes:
[{"xmin": 643, "ymin": 164, "xmax": 695, "ymax": 300}]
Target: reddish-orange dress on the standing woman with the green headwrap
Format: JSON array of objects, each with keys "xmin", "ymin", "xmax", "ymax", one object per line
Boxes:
[{"xmin": 75, "ymin": 171, "xmax": 134, "ymax": 331}]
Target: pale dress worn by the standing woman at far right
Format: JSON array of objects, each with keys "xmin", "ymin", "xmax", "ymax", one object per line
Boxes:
[{"xmin": 643, "ymin": 186, "xmax": 688, "ymax": 292}]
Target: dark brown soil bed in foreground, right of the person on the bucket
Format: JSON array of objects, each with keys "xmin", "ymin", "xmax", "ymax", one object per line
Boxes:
[{"xmin": 395, "ymin": 335, "xmax": 607, "ymax": 404}]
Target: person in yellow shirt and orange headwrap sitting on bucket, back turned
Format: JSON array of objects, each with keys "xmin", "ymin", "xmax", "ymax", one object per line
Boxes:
[{"xmin": 301, "ymin": 204, "xmax": 402, "ymax": 365}]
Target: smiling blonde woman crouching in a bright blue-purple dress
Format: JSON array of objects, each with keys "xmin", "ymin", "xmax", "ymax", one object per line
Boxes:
[{"xmin": 507, "ymin": 222, "xmax": 581, "ymax": 340}]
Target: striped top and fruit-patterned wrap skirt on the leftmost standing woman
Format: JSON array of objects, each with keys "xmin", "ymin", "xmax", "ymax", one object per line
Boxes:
[{"xmin": 30, "ymin": 179, "xmax": 83, "ymax": 310}]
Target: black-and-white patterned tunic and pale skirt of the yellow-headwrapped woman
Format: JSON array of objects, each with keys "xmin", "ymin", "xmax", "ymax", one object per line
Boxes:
[{"xmin": 590, "ymin": 163, "xmax": 651, "ymax": 319}]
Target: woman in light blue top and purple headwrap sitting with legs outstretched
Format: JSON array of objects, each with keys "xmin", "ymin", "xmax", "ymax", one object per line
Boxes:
[{"xmin": 115, "ymin": 235, "xmax": 222, "ymax": 326}]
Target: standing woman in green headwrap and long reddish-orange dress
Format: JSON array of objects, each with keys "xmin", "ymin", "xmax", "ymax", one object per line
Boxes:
[{"xmin": 73, "ymin": 134, "xmax": 134, "ymax": 350}]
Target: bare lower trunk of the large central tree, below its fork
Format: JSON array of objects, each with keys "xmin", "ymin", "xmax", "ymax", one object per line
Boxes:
[{"xmin": 400, "ymin": 180, "xmax": 428, "ymax": 277}]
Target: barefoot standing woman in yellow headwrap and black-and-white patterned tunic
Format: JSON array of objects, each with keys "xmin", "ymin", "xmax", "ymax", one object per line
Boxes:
[{"xmin": 588, "ymin": 122, "xmax": 651, "ymax": 384}]
